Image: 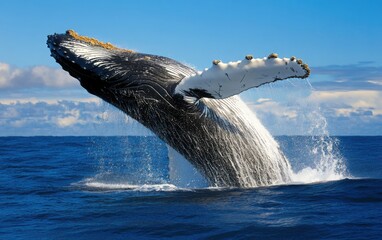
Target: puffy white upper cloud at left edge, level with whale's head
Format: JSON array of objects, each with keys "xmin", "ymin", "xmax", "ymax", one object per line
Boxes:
[{"xmin": 0, "ymin": 62, "xmax": 79, "ymax": 89}]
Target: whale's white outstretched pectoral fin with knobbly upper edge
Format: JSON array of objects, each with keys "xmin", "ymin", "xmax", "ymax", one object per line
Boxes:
[{"xmin": 175, "ymin": 53, "xmax": 310, "ymax": 99}]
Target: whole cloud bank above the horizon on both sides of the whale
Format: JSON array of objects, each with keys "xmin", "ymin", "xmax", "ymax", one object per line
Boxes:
[{"xmin": 0, "ymin": 62, "xmax": 382, "ymax": 136}]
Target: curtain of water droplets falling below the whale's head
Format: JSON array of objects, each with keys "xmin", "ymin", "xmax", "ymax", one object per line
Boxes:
[{"xmin": 85, "ymin": 136, "xmax": 168, "ymax": 188}]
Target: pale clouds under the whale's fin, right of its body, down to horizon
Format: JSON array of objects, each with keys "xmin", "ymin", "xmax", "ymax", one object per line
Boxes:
[{"xmin": 243, "ymin": 89, "xmax": 382, "ymax": 135}]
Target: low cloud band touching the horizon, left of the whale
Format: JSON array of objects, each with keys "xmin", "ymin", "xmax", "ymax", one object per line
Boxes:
[{"xmin": 0, "ymin": 98, "xmax": 150, "ymax": 136}]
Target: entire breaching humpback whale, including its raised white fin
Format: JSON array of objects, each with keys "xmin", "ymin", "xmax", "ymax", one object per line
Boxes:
[{"xmin": 47, "ymin": 30, "xmax": 310, "ymax": 187}]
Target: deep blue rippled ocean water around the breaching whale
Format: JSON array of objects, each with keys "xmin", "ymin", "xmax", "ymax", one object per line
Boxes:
[{"xmin": 0, "ymin": 137, "xmax": 382, "ymax": 239}]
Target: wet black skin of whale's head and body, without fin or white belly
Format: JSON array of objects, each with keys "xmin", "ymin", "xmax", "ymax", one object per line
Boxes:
[{"xmin": 47, "ymin": 34, "xmax": 290, "ymax": 187}]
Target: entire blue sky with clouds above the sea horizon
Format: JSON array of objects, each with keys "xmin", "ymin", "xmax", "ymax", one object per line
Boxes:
[{"xmin": 0, "ymin": 0, "xmax": 382, "ymax": 136}]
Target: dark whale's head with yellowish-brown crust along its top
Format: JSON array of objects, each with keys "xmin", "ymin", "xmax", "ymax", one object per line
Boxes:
[{"xmin": 47, "ymin": 30, "xmax": 195, "ymax": 115}]
